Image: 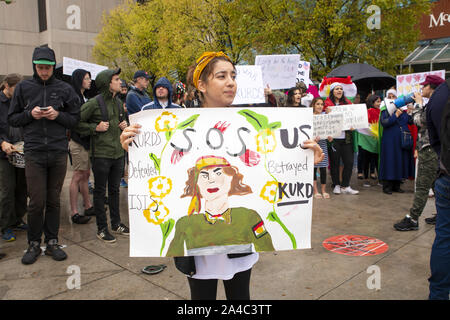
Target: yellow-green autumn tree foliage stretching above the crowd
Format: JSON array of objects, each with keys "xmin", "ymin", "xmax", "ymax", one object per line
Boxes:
[{"xmin": 93, "ymin": 0, "xmax": 430, "ymax": 83}]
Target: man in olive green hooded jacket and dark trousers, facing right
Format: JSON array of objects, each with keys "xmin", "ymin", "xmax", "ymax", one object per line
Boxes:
[{"xmin": 76, "ymin": 68, "xmax": 130, "ymax": 243}]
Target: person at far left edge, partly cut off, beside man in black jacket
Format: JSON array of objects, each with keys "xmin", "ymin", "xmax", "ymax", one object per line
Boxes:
[{"xmin": 0, "ymin": 73, "xmax": 27, "ymax": 242}]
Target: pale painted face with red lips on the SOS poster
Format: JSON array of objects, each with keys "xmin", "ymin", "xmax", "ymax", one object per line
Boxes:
[{"xmin": 197, "ymin": 167, "xmax": 233, "ymax": 201}]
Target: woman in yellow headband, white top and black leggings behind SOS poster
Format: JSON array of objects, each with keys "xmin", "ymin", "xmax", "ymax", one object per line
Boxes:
[{"xmin": 120, "ymin": 52, "xmax": 324, "ymax": 300}]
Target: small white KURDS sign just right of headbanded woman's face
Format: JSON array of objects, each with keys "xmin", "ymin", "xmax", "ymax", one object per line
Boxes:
[{"xmin": 233, "ymin": 66, "xmax": 266, "ymax": 104}]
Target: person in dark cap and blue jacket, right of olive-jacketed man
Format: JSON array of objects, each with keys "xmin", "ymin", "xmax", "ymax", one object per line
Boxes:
[{"xmin": 125, "ymin": 70, "xmax": 152, "ymax": 115}]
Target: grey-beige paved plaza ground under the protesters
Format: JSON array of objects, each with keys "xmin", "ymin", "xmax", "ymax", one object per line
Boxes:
[{"xmin": 0, "ymin": 164, "xmax": 435, "ymax": 300}]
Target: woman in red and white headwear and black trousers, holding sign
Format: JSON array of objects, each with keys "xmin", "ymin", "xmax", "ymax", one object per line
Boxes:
[{"xmin": 325, "ymin": 79, "xmax": 359, "ymax": 194}]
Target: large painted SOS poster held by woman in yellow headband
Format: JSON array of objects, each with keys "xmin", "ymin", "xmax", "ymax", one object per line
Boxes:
[{"xmin": 128, "ymin": 108, "xmax": 314, "ymax": 257}]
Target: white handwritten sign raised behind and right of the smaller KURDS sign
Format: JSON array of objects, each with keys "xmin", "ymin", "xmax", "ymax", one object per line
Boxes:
[{"xmin": 255, "ymin": 54, "xmax": 300, "ymax": 90}]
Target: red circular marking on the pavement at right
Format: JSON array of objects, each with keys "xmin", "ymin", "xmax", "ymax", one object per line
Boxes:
[{"xmin": 322, "ymin": 235, "xmax": 389, "ymax": 256}]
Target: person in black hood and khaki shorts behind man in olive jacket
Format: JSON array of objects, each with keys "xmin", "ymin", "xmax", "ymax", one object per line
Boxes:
[{"xmin": 69, "ymin": 69, "xmax": 95, "ymax": 224}]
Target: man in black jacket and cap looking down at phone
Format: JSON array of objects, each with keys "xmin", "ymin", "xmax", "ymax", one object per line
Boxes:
[{"xmin": 8, "ymin": 47, "xmax": 81, "ymax": 264}]
